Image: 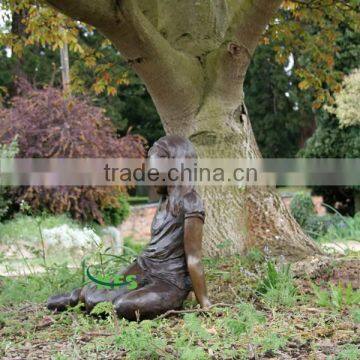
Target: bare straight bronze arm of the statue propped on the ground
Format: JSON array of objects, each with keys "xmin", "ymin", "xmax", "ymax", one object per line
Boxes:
[{"xmin": 184, "ymin": 217, "xmax": 211, "ymax": 308}]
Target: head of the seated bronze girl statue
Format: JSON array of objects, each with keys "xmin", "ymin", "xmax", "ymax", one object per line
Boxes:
[{"xmin": 148, "ymin": 135, "xmax": 197, "ymax": 194}]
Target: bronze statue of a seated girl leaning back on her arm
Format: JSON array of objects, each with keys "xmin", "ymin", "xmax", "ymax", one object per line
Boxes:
[{"xmin": 47, "ymin": 136, "xmax": 210, "ymax": 320}]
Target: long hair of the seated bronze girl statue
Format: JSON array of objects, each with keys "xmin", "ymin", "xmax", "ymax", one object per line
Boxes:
[{"xmin": 148, "ymin": 135, "xmax": 197, "ymax": 216}]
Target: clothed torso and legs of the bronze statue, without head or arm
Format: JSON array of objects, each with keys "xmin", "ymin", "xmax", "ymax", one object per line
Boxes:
[{"xmin": 48, "ymin": 189, "xmax": 205, "ymax": 320}]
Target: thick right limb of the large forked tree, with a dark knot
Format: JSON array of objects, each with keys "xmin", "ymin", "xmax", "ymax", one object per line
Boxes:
[{"xmin": 200, "ymin": 0, "xmax": 282, "ymax": 113}]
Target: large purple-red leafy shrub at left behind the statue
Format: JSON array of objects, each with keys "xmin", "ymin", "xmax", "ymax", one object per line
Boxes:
[{"xmin": 0, "ymin": 81, "xmax": 145, "ymax": 224}]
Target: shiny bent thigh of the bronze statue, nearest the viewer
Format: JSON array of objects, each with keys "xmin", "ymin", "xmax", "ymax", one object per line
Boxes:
[{"xmin": 113, "ymin": 279, "xmax": 189, "ymax": 320}]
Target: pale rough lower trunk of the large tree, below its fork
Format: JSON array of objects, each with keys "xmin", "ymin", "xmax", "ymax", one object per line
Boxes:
[{"xmin": 180, "ymin": 99, "xmax": 319, "ymax": 259}]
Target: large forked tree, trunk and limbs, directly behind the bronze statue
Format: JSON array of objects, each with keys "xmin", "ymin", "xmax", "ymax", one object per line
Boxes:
[{"xmin": 43, "ymin": 0, "xmax": 320, "ymax": 259}]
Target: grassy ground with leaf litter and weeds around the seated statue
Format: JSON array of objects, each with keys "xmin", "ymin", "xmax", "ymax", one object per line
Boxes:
[{"xmin": 0, "ymin": 252, "xmax": 359, "ymax": 360}]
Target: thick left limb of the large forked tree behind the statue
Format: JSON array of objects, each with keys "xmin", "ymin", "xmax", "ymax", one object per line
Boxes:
[{"xmin": 45, "ymin": 0, "xmax": 204, "ymax": 133}]
